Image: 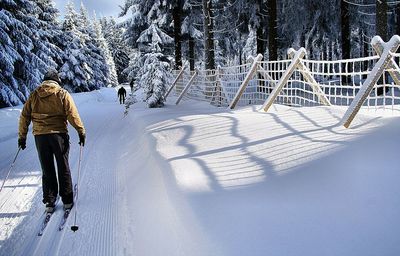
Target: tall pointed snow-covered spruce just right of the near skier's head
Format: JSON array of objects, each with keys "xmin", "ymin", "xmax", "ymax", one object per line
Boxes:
[{"xmin": 60, "ymin": 1, "xmax": 93, "ymax": 92}]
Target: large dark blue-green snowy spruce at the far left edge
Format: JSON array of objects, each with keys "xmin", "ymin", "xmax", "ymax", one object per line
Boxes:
[{"xmin": 0, "ymin": 0, "xmax": 58, "ymax": 107}]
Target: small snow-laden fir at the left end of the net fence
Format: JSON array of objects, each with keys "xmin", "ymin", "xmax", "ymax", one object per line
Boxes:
[{"xmin": 137, "ymin": 23, "xmax": 173, "ymax": 108}]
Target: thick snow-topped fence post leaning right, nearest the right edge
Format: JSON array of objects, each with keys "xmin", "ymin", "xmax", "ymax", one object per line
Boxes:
[{"xmin": 342, "ymin": 35, "xmax": 400, "ymax": 128}]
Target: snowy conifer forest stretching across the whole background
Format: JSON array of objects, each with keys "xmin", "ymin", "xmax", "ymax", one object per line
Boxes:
[{"xmin": 0, "ymin": 0, "xmax": 400, "ymax": 107}]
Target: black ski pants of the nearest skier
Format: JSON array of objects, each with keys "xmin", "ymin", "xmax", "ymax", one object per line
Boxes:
[{"xmin": 35, "ymin": 133, "xmax": 74, "ymax": 204}]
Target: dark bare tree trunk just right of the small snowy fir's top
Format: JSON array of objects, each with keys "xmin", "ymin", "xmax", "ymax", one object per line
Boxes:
[{"xmin": 172, "ymin": 0, "xmax": 183, "ymax": 69}]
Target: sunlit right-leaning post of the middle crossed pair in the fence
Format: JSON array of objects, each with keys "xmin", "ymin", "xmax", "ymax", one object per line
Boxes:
[{"xmin": 262, "ymin": 47, "xmax": 306, "ymax": 112}]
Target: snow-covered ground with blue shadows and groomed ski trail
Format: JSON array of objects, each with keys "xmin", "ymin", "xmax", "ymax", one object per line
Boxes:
[{"xmin": 0, "ymin": 88, "xmax": 400, "ymax": 256}]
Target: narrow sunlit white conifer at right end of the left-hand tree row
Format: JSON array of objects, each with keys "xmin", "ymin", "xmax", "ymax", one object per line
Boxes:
[{"xmin": 92, "ymin": 14, "xmax": 118, "ymax": 87}]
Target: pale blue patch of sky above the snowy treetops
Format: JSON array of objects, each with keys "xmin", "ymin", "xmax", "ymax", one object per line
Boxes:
[{"xmin": 54, "ymin": 0, "xmax": 125, "ymax": 20}]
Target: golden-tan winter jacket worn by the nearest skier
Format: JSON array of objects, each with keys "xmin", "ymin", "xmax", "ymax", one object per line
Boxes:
[{"xmin": 18, "ymin": 80, "xmax": 85, "ymax": 138}]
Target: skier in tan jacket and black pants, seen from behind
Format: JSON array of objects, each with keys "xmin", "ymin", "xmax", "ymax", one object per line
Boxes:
[{"xmin": 18, "ymin": 69, "xmax": 86, "ymax": 212}]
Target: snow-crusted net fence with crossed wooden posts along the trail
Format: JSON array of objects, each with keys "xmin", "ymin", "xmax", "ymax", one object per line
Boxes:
[{"xmin": 170, "ymin": 36, "xmax": 400, "ymax": 127}]
